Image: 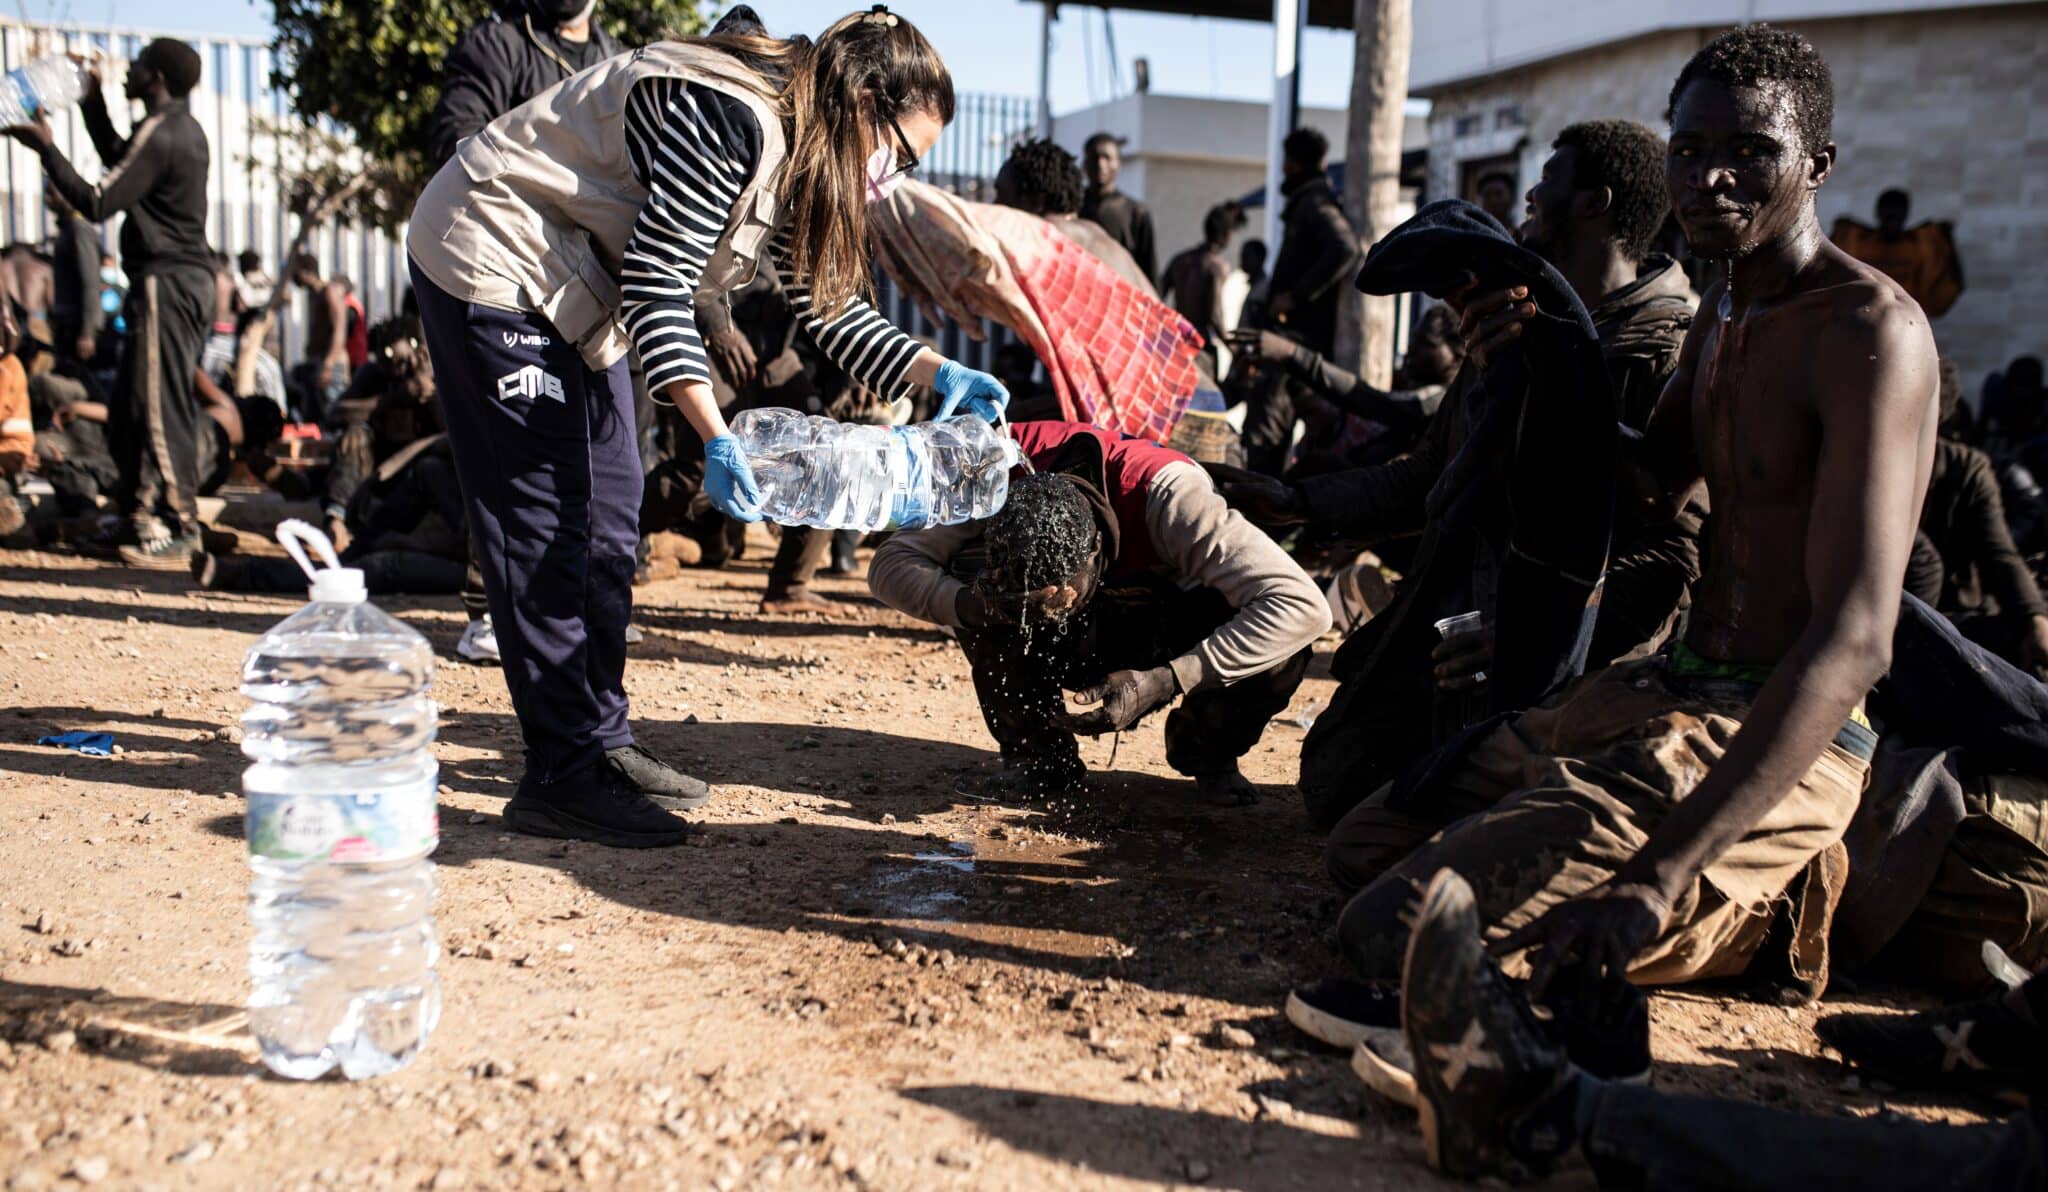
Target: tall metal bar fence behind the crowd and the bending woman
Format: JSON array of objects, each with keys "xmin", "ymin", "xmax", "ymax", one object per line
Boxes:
[{"xmin": 0, "ymin": 20, "xmax": 1036, "ymax": 369}]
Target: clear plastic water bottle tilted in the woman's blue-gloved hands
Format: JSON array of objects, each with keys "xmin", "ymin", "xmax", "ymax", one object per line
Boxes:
[{"xmin": 733, "ymin": 410, "xmax": 1018, "ymax": 530}]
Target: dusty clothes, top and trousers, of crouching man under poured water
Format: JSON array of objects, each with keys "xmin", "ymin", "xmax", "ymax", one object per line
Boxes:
[{"xmin": 868, "ymin": 422, "xmax": 1329, "ymax": 786}]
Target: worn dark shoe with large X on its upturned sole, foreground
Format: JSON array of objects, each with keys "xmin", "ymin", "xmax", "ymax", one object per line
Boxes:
[{"xmin": 1401, "ymin": 868, "xmax": 1577, "ymax": 1184}]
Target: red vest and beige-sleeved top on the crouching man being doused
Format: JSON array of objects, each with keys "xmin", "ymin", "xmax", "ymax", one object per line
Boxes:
[{"xmin": 868, "ymin": 422, "xmax": 1329, "ymax": 692}]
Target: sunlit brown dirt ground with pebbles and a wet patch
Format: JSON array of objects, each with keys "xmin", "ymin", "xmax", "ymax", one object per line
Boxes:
[{"xmin": 0, "ymin": 543, "xmax": 1985, "ymax": 1188}]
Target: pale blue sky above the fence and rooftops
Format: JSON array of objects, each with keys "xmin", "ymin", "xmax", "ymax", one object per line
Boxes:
[{"xmin": 36, "ymin": 0, "xmax": 1352, "ymax": 111}]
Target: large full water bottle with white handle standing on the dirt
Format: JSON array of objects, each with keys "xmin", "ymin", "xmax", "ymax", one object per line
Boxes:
[{"xmin": 242, "ymin": 520, "xmax": 440, "ymax": 1079}]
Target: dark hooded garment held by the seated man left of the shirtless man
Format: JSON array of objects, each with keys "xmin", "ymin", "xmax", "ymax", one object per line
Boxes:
[{"xmin": 1300, "ymin": 201, "xmax": 1654, "ymax": 825}]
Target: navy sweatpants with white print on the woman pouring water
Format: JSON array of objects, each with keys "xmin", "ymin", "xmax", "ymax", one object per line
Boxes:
[{"xmin": 412, "ymin": 268, "xmax": 643, "ymax": 782}]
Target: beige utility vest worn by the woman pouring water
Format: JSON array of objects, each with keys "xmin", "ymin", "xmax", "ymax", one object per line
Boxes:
[{"xmin": 406, "ymin": 41, "xmax": 788, "ymax": 371}]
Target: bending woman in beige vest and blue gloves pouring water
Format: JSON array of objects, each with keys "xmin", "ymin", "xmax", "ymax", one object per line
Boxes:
[{"xmin": 406, "ymin": 4, "xmax": 1010, "ymax": 848}]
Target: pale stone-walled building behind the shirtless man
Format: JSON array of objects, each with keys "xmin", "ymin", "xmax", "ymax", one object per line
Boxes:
[{"xmin": 1409, "ymin": 0, "xmax": 2048, "ymax": 393}]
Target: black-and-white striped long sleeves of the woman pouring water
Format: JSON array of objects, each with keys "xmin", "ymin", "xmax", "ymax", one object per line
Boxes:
[{"xmin": 621, "ymin": 78, "xmax": 922, "ymax": 399}]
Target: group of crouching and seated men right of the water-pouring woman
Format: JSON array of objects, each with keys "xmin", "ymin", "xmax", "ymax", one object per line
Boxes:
[{"xmin": 870, "ymin": 27, "xmax": 2048, "ymax": 1188}]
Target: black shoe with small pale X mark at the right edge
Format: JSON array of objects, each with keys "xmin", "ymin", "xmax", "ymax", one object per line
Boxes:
[{"xmin": 1815, "ymin": 993, "xmax": 2048, "ymax": 1094}]
